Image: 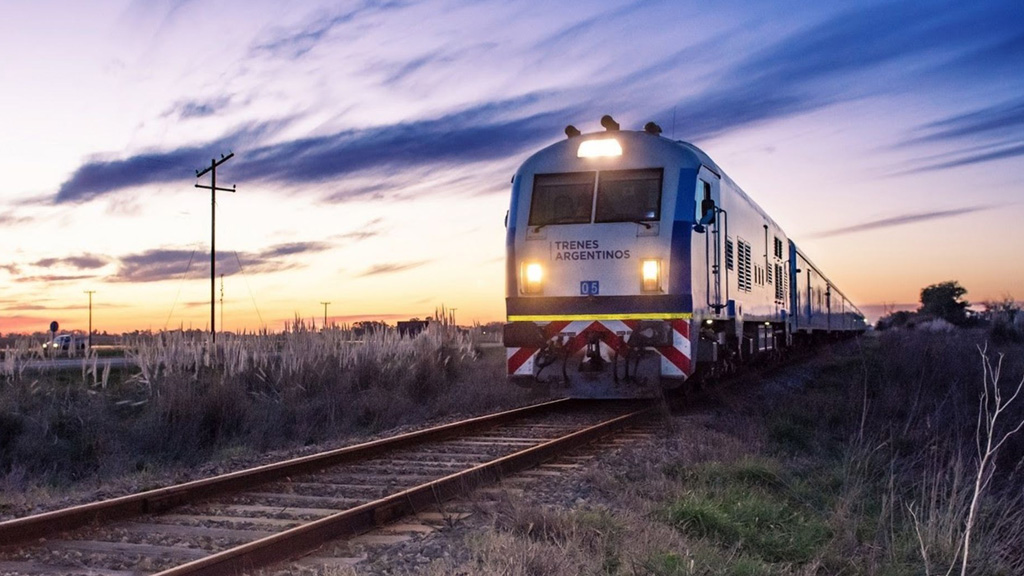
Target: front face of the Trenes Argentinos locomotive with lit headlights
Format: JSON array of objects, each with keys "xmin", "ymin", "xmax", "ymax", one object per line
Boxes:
[{"xmin": 504, "ymin": 117, "xmax": 700, "ymax": 398}]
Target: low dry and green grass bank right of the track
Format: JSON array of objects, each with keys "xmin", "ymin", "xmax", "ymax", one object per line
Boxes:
[{"xmin": 385, "ymin": 330, "xmax": 1024, "ymax": 576}]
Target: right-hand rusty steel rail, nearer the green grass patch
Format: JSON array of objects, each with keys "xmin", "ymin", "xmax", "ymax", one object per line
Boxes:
[{"xmin": 155, "ymin": 407, "xmax": 654, "ymax": 576}]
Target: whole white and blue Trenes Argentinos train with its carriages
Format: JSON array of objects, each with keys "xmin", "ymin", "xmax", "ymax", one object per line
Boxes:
[{"xmin": 502, "ymin": 116, "xmax": 867, "ymax": 398}]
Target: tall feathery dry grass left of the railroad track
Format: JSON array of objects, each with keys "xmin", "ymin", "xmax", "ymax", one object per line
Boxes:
[{"xmin": 0, "ymin": 313, "xmax": 528, "ymax": 494}]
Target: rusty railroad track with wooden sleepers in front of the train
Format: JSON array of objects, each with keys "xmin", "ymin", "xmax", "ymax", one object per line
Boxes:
[{"xmin": 0, "ymin": 400, "xmax": 653, "ymax": 576}]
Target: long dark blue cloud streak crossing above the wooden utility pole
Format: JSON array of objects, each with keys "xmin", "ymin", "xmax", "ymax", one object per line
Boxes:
[{"xmin": 55, "ymin": 95, "xmax": 571, "ymax": 203}]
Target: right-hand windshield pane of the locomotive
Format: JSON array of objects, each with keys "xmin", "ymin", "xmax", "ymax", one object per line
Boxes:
[{"xmin": 594, "ymin": 168, "xmax": 662, "ymax": 222}]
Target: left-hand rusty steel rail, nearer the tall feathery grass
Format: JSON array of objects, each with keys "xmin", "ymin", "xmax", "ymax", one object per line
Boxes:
[{"xmin": 0, "ymin": 399, "xmax": 577, "ymax": 547}]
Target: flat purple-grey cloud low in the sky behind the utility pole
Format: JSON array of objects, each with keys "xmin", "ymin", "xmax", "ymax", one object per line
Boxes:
[{"xmin": 109, "ymin": 242, "xmax": 331, "ymax": 282}]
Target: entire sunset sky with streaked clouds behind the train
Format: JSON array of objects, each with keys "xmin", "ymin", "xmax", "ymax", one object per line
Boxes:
[{"xmin": 0, "ymin": 0, "xmax": 1024, "ymax": 333}]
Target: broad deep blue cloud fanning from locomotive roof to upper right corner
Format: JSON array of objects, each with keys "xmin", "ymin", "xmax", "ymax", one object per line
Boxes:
[{"xmin": 660, "ymin": 2, "xmax": 1020, "ymax": 139}]
